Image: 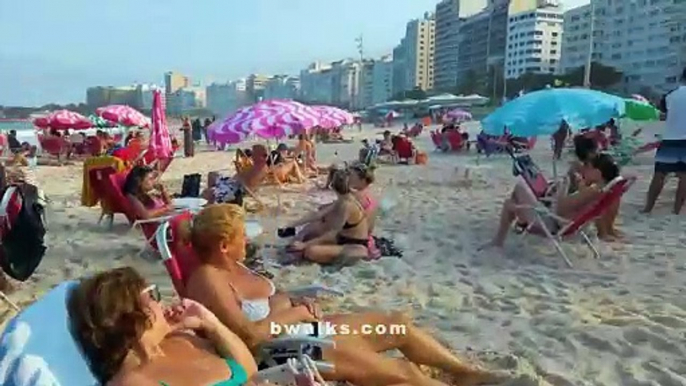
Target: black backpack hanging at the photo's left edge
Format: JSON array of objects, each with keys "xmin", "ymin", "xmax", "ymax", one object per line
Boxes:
[{"xmin": 0, "ymin": 184, "xmax": 47, "ymax": 281}]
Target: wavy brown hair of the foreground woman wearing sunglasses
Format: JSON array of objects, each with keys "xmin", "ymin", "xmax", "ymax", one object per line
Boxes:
[{"xmin": 67, "ymin": 267, "xmax": 151, "ymax": 384}]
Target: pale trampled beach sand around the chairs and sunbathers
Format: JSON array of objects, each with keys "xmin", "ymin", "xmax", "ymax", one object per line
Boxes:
[{"xmin": 0, "ymin": 124, "xmax": 686, "ymax": 386}]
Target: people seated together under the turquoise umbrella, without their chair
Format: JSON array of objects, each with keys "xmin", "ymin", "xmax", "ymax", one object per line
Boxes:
[{"xmin": 491, "ymin": 136, "xmax": 621, "ymax": 247}]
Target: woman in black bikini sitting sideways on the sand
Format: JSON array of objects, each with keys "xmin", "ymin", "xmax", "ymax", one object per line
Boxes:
[{"xmin": 290, "ymin": 170, "xmax": 369, "ymax": 264}]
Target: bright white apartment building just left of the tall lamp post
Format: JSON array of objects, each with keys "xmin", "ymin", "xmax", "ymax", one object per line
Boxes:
[{"xmin": 504, "ymin": 7, "xmax": 563, "ymax": 79}]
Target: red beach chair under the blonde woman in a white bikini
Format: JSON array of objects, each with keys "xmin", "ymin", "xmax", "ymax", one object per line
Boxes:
[{"xmin": 155, "ymin": 217, "xmax": 343, "ymax": 371}]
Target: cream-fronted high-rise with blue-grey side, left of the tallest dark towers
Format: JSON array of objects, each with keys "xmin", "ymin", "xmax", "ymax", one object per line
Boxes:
[{"xmin": 393, "ymin": 13, "xmax": 436, "ymax": 93}]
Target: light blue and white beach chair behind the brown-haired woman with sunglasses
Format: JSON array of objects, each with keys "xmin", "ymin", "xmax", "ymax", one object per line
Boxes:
[{"xmin": 0, "ymin": 281, "xmax": 333, "ymax": 386}]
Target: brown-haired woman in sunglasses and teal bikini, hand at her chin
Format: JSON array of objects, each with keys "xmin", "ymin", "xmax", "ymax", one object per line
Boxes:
[{"xmin": 67, "ymin": 267, "xmax": 264, "ymax": 386}]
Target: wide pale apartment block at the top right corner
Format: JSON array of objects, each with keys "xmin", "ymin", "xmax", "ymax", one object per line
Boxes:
[{"xmin": 563, "ymin": 0, "xmax": 686, "ymax": 93}]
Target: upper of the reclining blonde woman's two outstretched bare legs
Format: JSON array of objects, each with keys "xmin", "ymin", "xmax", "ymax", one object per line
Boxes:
[{"xmin": 325, "ymin": 312, "xmax": 504, "ymax": 385}]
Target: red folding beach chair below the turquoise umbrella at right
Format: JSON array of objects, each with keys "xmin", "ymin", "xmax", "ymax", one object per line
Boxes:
[{"xmin": 518, "ymin": 176, "xmax": 636, "ymax": 268}]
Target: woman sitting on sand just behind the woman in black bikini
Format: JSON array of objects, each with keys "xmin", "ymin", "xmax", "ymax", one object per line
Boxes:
[{"xmin": 281, "ymin": 163, "xmax": 377, "ymax": 242}]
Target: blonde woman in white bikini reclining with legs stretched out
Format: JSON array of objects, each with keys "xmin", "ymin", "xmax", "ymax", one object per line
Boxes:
[{"xmin": 182, "ymin": 205, "xmax": 503, "ymax": 386}]
